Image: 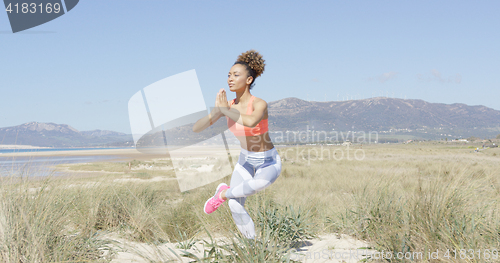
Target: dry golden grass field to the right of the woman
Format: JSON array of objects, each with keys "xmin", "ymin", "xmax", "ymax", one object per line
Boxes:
[{"xmin": 272, "ymin": 142, "xmax": 500, "ymax": 262}]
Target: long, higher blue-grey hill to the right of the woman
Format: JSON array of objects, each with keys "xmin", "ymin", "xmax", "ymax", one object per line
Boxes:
[{"xmin": 268, "ymin": 97, "xmax": 500, "ymax": 137}]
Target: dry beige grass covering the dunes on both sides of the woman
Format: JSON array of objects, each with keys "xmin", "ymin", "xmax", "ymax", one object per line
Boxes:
[{"xmin": 0, "ymin": 142, "xmax": 500, "ymax": 262}]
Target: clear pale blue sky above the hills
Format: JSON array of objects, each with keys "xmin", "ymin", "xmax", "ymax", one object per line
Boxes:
[{"xmin": 0, "ymin": 0, "xmax": 500, "ymax": 133}]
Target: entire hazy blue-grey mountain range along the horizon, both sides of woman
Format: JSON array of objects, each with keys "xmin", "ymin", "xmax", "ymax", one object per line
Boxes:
[{"xmin": 0, "ymin": 97, "xmax": 500, "ymax": 147}]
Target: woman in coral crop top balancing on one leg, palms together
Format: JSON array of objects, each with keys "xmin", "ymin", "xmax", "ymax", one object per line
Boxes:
[{"xmin": 193, "ymin": 50, "xmax": 281, "ymax": 239}]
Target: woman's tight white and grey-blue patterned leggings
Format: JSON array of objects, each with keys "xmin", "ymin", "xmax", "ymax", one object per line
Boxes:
[{"xmin": 226, "ymin": 148, "xmax": 281, "ymax": 239}]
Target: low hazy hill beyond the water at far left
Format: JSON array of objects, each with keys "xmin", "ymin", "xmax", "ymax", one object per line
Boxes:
[{"xmin": 0, "ymin": 122, "xmax": 132, "ymax": 147}]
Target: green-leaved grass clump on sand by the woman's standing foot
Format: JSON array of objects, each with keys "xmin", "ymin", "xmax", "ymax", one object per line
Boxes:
[{"xmin": 172, "ymin": 198, "xmax": 315, "ymax": 263}]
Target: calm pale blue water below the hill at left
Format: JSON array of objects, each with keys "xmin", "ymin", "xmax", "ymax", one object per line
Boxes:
[{"xmin": 0, "ymin": 148, "xmax": 128, "ymax": 176}]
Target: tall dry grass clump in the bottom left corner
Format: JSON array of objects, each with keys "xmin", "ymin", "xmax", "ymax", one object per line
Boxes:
[{"xmin": 0, "ymin": 177, "xmax": 106, "ymax": 262}]
